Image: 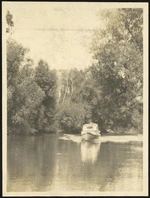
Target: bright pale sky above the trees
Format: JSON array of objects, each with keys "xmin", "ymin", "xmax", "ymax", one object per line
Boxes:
[{"xmin": 2, "ymin": 2, "xmax": 105, "ymax": 69}]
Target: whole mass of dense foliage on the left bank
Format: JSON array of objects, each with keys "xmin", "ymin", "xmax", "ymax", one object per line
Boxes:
[{"xmin": 7, "ymin": 39, "xmax": 57, "ymax": 133}]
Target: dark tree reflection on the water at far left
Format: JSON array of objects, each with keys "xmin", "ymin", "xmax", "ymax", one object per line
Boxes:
[{"xmin": 8, "ymin": 135, "xmax": 57, "ymax": 191}]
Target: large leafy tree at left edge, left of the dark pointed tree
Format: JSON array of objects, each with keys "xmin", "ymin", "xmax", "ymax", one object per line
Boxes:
[{"xmin": 7, "ymin": 39, "xmax": 44, "ymax": 133}]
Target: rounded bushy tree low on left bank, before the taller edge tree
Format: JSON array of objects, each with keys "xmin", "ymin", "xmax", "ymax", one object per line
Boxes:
[{"xmin": 12, "ymin": 78, "xmax": 44, "ymax": 133}]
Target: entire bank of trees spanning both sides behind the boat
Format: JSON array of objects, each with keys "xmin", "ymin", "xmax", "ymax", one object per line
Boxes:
[{"xmin": 7, "ymin": 9, "xmax": 143, "ymax": 134}]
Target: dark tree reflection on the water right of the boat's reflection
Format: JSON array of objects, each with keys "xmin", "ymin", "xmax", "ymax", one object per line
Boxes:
[{"xmin": 95, "ymin": 142, "xmax": 142, "ymax": 190}]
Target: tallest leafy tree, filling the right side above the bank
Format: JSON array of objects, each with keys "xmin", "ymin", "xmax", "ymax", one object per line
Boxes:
[{"xmin": 91, "ymin": 9, "xmax": 143, "ymax": 131}]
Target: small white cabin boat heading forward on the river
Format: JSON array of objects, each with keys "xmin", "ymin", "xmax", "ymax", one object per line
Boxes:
[{"xmin": 81, "ymin": 122, "xmax": 100, "ymax": 141}]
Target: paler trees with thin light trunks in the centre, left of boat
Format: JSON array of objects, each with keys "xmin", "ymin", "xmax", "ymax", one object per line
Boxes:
[{"xmin": 55, "ymin": 68, "xmax": 95, "ymax": 133}]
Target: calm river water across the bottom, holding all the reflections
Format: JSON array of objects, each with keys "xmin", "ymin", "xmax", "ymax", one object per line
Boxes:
[{"xmin": 7, "ymin": 134, "xmax": 143, "ymax": 192}]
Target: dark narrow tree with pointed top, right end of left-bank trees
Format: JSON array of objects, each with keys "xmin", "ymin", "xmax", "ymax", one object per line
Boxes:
[{"xmin": 35, "ymin": 60, "xmax": 57, "ymax": 131}]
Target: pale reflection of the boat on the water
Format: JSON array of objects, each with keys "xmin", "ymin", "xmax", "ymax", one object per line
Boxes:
[{"xmin": 81, "ymin": 141, "xmax": 101, "ymax": 164}]
